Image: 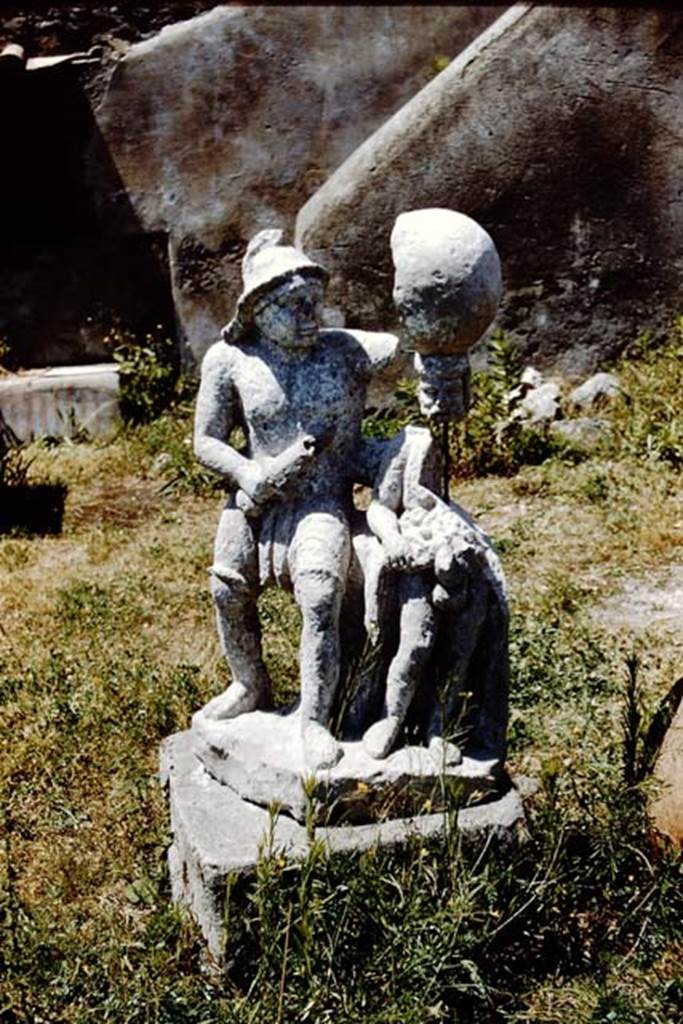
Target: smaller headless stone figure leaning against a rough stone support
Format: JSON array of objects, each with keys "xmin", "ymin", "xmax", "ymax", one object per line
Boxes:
[{"xmin": 347, "ymin": 419, "xmax": 507, "ymax": 765}]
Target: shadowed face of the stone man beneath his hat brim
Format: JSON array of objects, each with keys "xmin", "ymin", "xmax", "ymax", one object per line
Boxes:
[{"xmin": 254, "ymin": 274, "xmax": 324, "ymax": 348}]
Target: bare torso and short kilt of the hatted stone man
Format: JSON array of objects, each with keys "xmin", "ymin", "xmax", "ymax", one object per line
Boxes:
[{"xmin": 202, "ymin": 330, "xmax": 397, "ymax": 593}]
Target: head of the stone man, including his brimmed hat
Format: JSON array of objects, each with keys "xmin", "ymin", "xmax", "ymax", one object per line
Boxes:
[{"xmin": 222, "ymin": 230, "xmax": 329, "ymax": 348}]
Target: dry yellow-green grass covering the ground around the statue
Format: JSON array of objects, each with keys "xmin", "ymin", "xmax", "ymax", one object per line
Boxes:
[{"xmin": 0, "ymin": 326, "xmax": 683, "ymax": 1024}]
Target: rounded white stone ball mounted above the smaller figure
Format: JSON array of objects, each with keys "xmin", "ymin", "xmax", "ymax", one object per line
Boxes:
[{"xmin": 391, "ymin": 208, "xmax": 503, "ymax": 355}]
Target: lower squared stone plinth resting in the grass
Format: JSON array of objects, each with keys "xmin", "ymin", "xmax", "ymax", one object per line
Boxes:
[{"xmin": 161, "ymin": 731, "xmax": 525, "ymax": 961}]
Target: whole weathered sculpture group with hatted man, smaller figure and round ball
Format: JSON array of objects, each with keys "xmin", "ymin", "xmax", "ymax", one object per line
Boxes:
[{"xmin": 193, "ymin": 210, "xmax": 507, "ymax": 815}]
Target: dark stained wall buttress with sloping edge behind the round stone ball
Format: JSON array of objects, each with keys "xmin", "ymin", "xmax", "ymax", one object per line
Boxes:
[{"xmin": 297, "ymin": 5, "xmax": 683, "ymax": 374}]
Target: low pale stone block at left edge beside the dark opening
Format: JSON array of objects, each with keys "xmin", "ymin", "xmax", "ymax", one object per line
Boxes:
[{"xmin": 0, "ymin": 362, "xmax": 121, "ymax": 441}]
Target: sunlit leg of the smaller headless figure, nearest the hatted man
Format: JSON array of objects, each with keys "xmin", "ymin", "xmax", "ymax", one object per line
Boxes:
[{"xmin": 362, "ymin": 573, "xmax": 436, "ymax": 758}]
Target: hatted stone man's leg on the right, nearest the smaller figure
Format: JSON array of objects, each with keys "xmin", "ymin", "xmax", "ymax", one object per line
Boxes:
[{"xmin": 290, "ymin": 513, "xmax": 350, "ymax": 771}]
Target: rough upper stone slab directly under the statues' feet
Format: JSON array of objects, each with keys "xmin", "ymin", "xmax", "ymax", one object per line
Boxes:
[{"xmin": 191, "ymin": 711, "xmax": 509, "ymax": 824}]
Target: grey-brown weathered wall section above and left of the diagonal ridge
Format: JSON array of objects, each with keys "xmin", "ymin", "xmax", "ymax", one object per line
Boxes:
[{"xmin": 91, "ymin": 5, "xmax": 498, "ymax": 360}]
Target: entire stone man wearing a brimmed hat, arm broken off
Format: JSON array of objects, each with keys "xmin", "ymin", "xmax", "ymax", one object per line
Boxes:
[{"xmin": 195, "ymin": 230, "xmax": 397, "ymax": 770}]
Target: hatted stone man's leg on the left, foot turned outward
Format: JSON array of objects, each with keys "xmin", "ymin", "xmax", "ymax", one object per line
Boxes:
[{"xmin": 198, "ymin": 508, "xmax": 270, "ymax": 719}]
